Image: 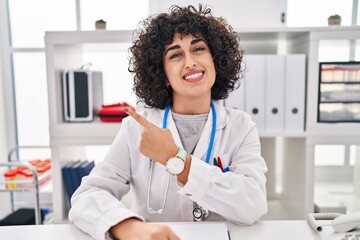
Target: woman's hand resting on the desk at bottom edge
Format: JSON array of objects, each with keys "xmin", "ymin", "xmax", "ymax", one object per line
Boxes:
[{"xmin": 110, "ymin": 218, "xmax": 180, "ymax": 240}]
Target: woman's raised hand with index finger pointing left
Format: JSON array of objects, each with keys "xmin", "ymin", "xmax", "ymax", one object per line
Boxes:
[{"xmin": 126, "ymin": 109, "xmax": 178, "ymax": 165}]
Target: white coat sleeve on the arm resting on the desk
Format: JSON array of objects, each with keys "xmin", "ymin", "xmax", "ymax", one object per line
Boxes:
[{"xmin": 69, "ymin": 118, "xmax": 144, "ymax": 239}]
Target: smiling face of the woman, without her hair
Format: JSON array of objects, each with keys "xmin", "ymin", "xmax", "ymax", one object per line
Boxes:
[{"xmin": 163, "ymin": 34, "xmax": 216, "ymax": 102}]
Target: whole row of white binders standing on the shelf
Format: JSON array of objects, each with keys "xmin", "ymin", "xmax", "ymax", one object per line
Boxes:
[{"xmin": 225, "ymin": 54, "xmax": 306, "ymax": 133}]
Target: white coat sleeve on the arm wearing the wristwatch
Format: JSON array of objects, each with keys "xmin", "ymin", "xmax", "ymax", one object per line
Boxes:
[{"xmin": 178, "ymin": 115, "xmax": 267, "ymax": 224}]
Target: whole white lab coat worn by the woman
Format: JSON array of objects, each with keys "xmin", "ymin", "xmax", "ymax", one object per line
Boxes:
[{"xmin": 69, "ymin": 101, "xmax": 267, "ymax": 239}]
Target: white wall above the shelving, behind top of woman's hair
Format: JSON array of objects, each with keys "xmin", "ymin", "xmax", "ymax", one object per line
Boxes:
[{"xmin": 150, "ymin": 0, "xmax": 287, "ymax": 30}]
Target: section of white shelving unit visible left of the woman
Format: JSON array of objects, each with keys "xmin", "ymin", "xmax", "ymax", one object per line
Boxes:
[{"xmin": 45, "ymin": 31, "xmax": 132, "ymax": 222}]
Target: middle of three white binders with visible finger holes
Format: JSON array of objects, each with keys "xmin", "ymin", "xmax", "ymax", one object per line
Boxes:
[{"xmin": 265, "ymin": 55, "xmax": 285, "ymax": 132}]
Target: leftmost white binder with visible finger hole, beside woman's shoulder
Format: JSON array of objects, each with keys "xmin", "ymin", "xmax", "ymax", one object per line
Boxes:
[{"xmin": 244, "ymin": 55, "xmax": 265, "ymax": 132}]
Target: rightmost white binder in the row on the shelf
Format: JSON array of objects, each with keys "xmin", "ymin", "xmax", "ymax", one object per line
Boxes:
[{"xmin": 285, "ymin": 54, "xmax": 306, "ymax": 132}]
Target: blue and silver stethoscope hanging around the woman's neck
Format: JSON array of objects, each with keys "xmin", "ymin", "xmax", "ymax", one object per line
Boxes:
[{"xmin": 146, "ymin": 102, "xmax": 216, "ymax": 221}]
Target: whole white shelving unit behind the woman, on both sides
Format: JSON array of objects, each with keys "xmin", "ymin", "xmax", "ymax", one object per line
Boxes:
[{"xmin": 45, "ymin": 27, "xmax": 360, "ymax": 223}]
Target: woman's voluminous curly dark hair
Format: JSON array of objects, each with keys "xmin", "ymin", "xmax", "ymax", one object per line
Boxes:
[{"xmin": 129, "ymin": 4, "xmax": 243, "ymax": 109}]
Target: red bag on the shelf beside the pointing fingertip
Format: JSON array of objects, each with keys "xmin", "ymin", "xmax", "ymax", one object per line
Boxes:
[{"xmin": 98, "ymin": 103, "xmax": 135, "ymax": 122}]
